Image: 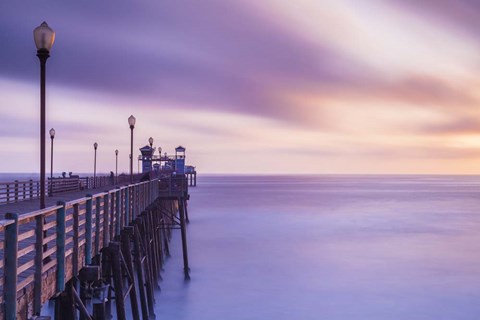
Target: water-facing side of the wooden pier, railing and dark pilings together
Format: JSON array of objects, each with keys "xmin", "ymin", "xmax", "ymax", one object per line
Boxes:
[{"xmin": 0, "ymin": 174, "xmax": 196, "ymax": 320}]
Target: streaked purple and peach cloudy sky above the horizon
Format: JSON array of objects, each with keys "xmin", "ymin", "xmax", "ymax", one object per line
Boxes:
[{"xmin": 0, "ymin": 0, "xmax": 480, "ymax": 174}]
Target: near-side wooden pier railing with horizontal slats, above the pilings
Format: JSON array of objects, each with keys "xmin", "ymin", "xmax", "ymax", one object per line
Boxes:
[{"xmin": 0, "ymin": 179, "xmax": 161, "ymax": 319}]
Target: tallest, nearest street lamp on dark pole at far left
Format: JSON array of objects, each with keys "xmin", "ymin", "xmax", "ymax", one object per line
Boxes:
[{"xmin": 33, "ymin": 21, "xmax": 55, "ymax": 209}]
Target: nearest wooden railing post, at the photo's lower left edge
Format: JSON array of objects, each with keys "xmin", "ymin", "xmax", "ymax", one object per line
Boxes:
[{"xmin": 3, "ymin": 213, "xmax": 18, "ymax": 320}]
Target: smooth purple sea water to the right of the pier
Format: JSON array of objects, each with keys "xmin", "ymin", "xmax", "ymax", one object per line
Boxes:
[{"xmin": 156, "ymin": 175, "xmax": 480, "ymax": 320}]
